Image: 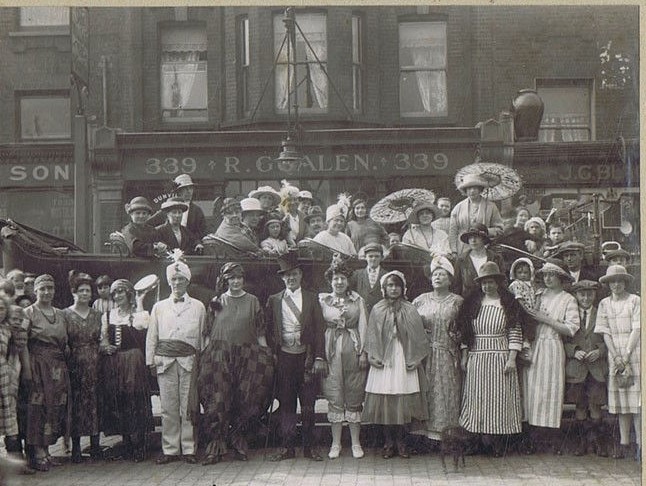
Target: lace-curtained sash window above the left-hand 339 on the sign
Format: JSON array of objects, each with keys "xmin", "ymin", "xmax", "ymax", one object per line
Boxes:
[{"xmin": 161, "ymin": 24, "xmax": 208, "ymax": 123}]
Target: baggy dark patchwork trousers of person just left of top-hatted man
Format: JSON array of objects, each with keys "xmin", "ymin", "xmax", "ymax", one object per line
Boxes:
[{"xmin": 198, "ymin": 340, "xmax": 274, "ymax": 455}]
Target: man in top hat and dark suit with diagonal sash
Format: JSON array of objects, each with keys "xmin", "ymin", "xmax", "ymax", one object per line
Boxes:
[{"xmin": 265, "ymin": 252, "xmax": 327, "ymax": 461}]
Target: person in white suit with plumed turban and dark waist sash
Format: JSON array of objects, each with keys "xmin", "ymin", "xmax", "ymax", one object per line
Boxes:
[{"xmin": 146, "ymin": 262, "xmax": 206, "ymax": 464}]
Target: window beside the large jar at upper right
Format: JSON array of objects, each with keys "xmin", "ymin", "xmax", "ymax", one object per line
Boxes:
[{"xmin": 536, "ymin": 79, "xmax": 594, "ymax": 142}]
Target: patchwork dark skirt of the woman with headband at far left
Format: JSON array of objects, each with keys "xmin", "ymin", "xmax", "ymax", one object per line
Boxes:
[{"xmin": 27, "ymin": 343, "xmax": 70, "ymax": 447}]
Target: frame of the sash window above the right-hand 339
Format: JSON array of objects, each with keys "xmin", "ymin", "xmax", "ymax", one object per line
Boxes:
[{"xmin": 397, "ymin": 16, "xmax": 450, "ymax": 121}]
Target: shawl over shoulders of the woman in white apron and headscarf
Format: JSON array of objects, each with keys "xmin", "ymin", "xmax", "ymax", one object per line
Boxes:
[{"xmin": 365, "ymin": 299, "xmax": 429, "ymax": 366}]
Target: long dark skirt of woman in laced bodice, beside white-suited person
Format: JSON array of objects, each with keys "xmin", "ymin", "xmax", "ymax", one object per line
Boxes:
[{"xmin": 99, "ymin": 349, "xmax": 153, "ymax": 439}]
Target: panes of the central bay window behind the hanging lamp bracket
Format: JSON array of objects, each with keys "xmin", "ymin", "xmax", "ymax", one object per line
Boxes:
[{"xmin": 274, "ymin": 13, "xmax": 328, "ymax": 113}]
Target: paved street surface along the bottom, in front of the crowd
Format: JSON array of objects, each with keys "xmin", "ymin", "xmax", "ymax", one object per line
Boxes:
[{"xmin": 0, "ymin": 438, "xmax": 641, "ymax": 486}]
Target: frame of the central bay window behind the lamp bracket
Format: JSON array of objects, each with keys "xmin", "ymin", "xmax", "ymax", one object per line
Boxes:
[{"xmin": 271, "ymin": 9, "xmax": 330, "ymax": 116}]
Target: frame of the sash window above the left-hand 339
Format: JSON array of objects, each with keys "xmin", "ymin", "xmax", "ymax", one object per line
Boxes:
[{"xmin": 157, "ymin": 20, "xmax": 209, "ymax": 128}]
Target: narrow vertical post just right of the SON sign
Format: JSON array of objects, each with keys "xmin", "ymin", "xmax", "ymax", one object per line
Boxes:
[{"xmin": 72, "ymin": 114, "xmax": 89, "ymax": 250}]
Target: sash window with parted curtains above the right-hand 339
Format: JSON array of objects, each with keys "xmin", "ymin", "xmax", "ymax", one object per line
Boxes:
[{"xmin": 399, "ymin": 22, "xmax": 448, "ymax": 117}]
